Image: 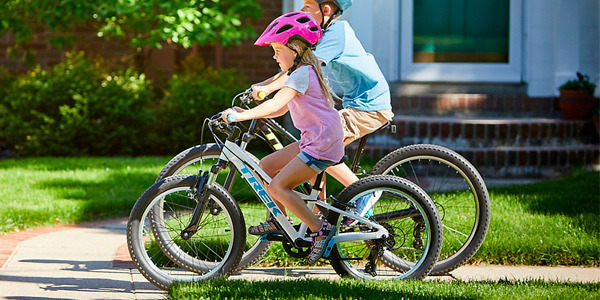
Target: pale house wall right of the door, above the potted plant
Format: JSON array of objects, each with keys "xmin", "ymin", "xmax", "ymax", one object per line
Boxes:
[{"xmin": 524, "ymin": 0, "xmax": 600, "ymax": 96}]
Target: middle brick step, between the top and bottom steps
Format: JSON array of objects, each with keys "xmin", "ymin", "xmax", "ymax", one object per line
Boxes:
[{"xmin": 378, "ymin": 115, "xmax": 598, "ymax": 148}]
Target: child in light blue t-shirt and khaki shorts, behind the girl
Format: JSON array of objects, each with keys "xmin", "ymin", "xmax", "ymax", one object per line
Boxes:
[{"xmin": 253, "ymin": 0, "xmax": 394, "ymax": 225}]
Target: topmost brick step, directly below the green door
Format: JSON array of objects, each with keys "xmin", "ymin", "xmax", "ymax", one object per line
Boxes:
[{"xmin": 392, "ymin": 94, "xmax": 562, "ymax": 118}]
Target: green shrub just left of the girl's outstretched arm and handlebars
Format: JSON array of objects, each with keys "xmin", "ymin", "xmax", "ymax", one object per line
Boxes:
[{"xmin": 156, "ymin": 56, "xmax": 249, "ymax": 154}]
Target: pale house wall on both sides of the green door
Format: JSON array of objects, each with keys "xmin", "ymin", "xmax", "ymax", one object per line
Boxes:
[{"xmin": 283, "ymin": 0, "xmax": 600, "ymax": 97}]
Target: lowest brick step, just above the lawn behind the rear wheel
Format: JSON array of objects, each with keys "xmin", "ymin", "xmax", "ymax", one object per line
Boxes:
[{"xmin": 350, "ymin": 144, "xmax": 600, "ymax": 179}]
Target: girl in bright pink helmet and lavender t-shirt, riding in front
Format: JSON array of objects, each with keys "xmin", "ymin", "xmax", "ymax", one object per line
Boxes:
[{"xmin": 222, "ymin": 12, "xmax": 344, "ymax": 264}]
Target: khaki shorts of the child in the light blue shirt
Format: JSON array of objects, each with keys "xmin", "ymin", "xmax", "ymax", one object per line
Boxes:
[{"xmin": 339, "ymin": 107, "xmax": 394, "ymax": 145}]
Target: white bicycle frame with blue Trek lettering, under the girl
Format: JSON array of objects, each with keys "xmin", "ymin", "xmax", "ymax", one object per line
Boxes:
[{"xmin": 207, "ymin": 129, "xmax": 389, "ymax": 243}]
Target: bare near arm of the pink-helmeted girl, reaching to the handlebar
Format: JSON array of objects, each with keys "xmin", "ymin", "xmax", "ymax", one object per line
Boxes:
[{"xmin": 221, "ymin": 87, "xmax": 298, "ymax": 122}]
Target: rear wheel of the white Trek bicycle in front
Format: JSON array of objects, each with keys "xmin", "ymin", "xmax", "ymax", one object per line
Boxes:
[{"xmin": 328, "ymin": 175, "xmax": 442, "ymax": 280}]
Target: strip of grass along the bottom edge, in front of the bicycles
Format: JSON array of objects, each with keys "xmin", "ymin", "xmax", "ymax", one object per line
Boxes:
[{"xmin": 169, "ymin": 279, "xmax": 600, "ymax": 300}]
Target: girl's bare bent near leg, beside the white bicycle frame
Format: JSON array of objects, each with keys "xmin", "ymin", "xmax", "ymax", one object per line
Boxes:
[{"xmin": 267, "ymin": 157, "xmax": 323, "ymax": 232}]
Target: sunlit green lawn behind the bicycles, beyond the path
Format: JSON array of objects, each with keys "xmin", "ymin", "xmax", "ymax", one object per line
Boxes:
[{"xmin": 0, "ymin": 157, "xmax": 600, "ymax": 266}]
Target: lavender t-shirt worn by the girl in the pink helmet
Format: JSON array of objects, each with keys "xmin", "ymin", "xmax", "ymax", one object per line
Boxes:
[{"xmin": 285, "ymin": 65, "xmax": 344, "ymax": 162}]
